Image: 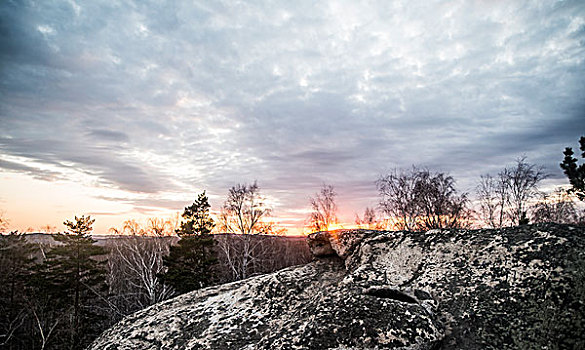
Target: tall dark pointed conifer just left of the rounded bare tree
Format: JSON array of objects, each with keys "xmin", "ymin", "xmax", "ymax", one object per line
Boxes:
[{"xmin": 161, "ymin": 191, "xmax": 217, "ymax": 293}]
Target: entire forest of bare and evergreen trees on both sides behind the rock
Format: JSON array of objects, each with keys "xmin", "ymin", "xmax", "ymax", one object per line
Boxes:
[{"xmin": 0, "ymin": 137, "xmax": 585, "ymax": 349}]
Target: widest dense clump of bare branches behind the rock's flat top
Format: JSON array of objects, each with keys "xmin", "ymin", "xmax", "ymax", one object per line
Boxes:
[{"xmin": 376, "ymin": 167, "xmax": 470, "ymax": 230}]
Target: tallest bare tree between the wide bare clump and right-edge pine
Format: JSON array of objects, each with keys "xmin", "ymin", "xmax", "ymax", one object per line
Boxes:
[{"xmin": 501, "ymin": 157, "xmax": 548, "ymax": 225}]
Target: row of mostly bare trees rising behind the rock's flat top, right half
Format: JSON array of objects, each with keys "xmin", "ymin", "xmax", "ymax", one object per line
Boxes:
[{"xmin": 307, "ymin": 137, "xmax": 585, "ymax": 231}]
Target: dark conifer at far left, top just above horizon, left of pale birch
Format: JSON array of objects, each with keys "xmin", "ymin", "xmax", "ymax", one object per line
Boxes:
[{"xmin": 33, "ymin": 216, "xmax": 107, "ymax": 349}]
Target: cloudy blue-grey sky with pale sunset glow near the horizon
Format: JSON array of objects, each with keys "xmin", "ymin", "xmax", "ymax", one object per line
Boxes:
[{"xmin": 0, "ymin": 0, "xmax": 585, "ymax": 232}]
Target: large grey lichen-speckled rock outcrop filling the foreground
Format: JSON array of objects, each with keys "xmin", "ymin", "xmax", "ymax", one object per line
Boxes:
[{"xmin": 90, "ymin": 224, "xmax": 585, "ymax": 350}]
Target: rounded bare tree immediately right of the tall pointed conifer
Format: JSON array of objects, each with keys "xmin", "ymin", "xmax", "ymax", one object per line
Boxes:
[{"xmin": 217, "ymin": 182, "xmax": 271, "ymax": 280}]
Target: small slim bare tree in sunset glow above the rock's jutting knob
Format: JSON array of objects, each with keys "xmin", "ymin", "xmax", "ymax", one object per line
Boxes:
[{"xmin": 309, "ymin": 184, "xmax": 337, "ymax": 232}]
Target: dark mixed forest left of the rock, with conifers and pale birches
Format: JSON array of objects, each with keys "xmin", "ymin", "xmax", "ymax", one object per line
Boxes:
[{"xmin": 0, "ymin": 187, "xmax": 312, "ymax": 349}]
